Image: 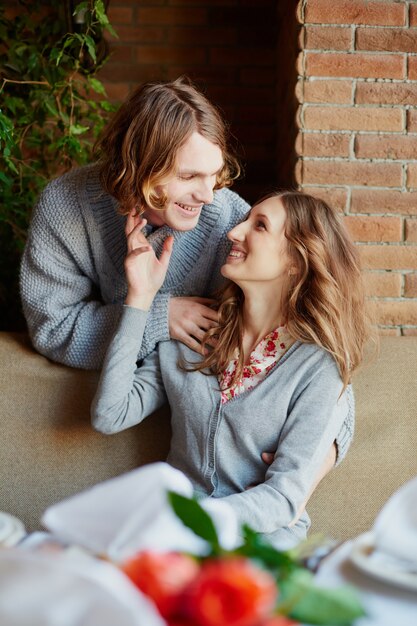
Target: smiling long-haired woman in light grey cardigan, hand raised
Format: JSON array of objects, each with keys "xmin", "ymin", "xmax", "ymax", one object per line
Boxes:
[{"xmin": 92, "ymin": 192, "xmax": 367, "ymax": 547}]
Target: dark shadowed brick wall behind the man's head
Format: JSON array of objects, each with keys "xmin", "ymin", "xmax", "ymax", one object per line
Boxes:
[{"xmin": 101, "ymin": 0, "xmax": 298, "ymax": 202}]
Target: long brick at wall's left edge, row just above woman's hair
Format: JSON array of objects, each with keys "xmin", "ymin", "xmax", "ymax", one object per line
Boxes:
[{"xmin": 301, "ymin": 159, "xmax": 402, "ymax": 187}]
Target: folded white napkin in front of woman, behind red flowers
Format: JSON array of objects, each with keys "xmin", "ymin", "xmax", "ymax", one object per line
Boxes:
[{"xmin": 42, "ymin": 463, "xmax": 239, "ymax": 562}]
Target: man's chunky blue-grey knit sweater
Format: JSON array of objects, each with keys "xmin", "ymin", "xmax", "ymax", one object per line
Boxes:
[{"xmin": 20, "ymin": 165, "xmax": 249, "ymax": 369}]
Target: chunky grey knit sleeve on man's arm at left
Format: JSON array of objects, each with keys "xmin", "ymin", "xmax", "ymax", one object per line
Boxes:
[{"xmin": 20, "ymin": 168, "xmax": 121, "ymax": 369}]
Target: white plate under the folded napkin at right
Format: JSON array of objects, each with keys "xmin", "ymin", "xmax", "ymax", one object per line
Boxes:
[{"xmin": 350, "ymin": 532, "xmax": 417, "ymax": 591}]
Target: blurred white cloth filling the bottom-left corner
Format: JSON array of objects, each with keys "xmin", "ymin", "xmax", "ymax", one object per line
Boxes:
[{"xmin": 0, "ymin": 548, "xmax": 165, "ymax": 626}]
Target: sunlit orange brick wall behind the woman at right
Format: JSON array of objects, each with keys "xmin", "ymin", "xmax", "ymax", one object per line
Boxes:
[{"xmin": 296, "ymin": 0, "xmax": 417, "ymax": 335}]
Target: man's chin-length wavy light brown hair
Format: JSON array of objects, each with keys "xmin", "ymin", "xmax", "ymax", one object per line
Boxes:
[{"xmin": 95, "ymin": 76, "xmax": 240, "ymax": 214}]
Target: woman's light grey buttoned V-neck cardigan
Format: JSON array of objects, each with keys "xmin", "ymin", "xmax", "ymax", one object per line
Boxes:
[{"xmin": 91, "ymin": 306, "xmax": 354, "ymax": 547}]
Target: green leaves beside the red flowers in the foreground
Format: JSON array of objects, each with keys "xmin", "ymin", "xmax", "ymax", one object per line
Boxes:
[{"xmin": 168, "ymin": 492, "xmax": 365, "ymax": 626}]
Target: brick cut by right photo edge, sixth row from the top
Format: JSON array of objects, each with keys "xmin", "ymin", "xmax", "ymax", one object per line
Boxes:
[{"xmin": 355, "ymin": 134, "xmax": 417, "ymax": 159}]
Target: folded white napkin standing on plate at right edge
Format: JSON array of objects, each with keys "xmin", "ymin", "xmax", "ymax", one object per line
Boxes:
[{"xmin": 372, "ymin": 476, "xmax": 417, "ymax": 572}]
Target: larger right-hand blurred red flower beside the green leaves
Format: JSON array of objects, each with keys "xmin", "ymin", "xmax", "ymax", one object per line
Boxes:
[{"xmin": 186, "ymin": 557, "xmax": 277, "ymax": 626}]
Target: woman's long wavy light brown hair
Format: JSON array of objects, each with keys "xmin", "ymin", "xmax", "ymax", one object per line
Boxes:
[{"xmin": 192, "ymin": 191, "xmax": 371, "ymax": 388}]
